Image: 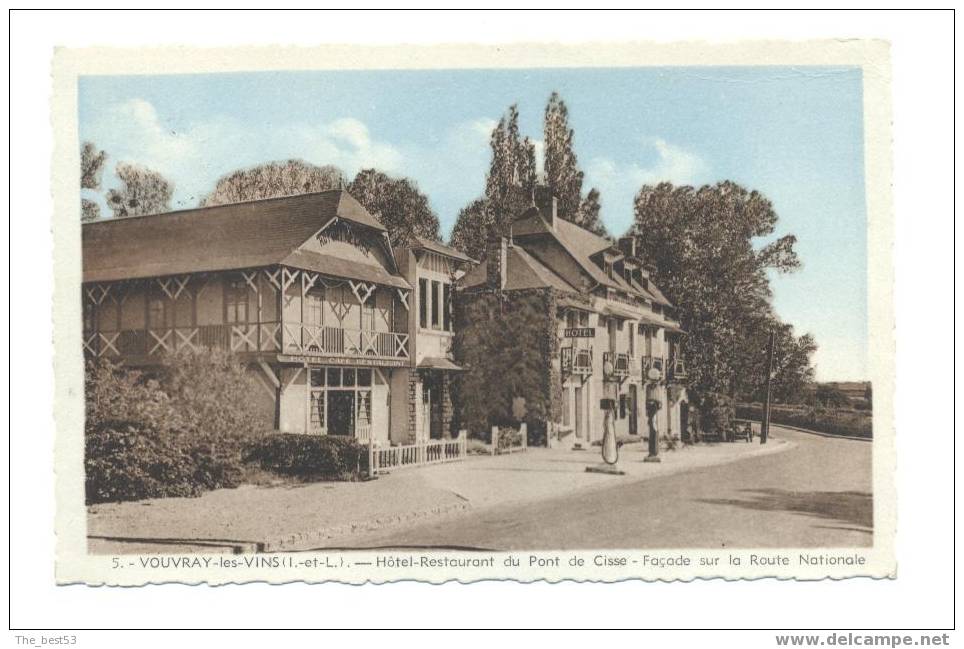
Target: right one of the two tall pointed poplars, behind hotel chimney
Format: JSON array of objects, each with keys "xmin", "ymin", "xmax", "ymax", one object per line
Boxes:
[{"xmin": 543, "ymin": 92, "xmax": 606, "ymax": 236}]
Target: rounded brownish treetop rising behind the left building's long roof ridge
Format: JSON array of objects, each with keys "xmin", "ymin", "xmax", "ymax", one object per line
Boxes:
[{"xmin": 201, "ymin": 160, "xmax": 345, "ymax": 207}]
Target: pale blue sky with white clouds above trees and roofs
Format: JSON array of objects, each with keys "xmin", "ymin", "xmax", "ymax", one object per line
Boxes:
[{"xmin": 79, "ymin": 66, "xmax": 868, "ymax": 380}]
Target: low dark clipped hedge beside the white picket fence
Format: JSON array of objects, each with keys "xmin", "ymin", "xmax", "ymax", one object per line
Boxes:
[{"xmin": 245, "ymin": 433, "xmax": 368, "ymax": 480}]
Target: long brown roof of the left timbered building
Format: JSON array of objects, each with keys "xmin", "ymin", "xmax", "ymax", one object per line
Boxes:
[{"xmin": 82, "ymin": 189, "xmax": 385, "ymax": 282}]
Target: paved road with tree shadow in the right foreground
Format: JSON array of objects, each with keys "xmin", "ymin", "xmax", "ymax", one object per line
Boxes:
[{"xmin": 316, "ymin": 427, "xmax": 873, "ymax": 550}]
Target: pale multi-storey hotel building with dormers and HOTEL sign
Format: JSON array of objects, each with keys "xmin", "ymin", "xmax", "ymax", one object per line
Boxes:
[{"xmin": 460, "ymin": 188, "xmax": 689, "ymax": 447}]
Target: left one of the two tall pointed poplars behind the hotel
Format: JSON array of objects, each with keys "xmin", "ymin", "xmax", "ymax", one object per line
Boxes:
[{"xmin": 452, "ymin": 104, "xmax": 536, "ymax": 259}]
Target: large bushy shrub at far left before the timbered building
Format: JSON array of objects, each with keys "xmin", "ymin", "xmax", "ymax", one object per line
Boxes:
[{"xmin": 84, "ymin": 351, "xmax": 256, "ymax": 504}]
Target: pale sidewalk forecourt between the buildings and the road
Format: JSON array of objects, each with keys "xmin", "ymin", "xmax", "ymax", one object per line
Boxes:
[{"xmin": 87, "ymin": 440, "xmax": 791, "ymax": 554}]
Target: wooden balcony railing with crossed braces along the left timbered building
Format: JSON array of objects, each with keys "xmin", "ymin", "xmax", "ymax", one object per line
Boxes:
[{"xmin": 84, "ymin": 322, "xmax": 409, "ymax": 359}]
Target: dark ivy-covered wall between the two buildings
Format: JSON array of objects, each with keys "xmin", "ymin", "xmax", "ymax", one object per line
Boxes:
[{"xmin": 452, "ymin": 289, "xmax": 562, "ymax": 444}]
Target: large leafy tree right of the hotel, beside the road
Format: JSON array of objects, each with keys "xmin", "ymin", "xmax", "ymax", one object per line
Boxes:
[{"xmin": 630, "ymin": 181, "xmax": 816, "ymax": 405}]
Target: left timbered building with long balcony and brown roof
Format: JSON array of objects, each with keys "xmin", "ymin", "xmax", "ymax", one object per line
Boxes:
[{"xmin": 83, "ymin": 190, "xmax": 470, "ymax": 444}]
